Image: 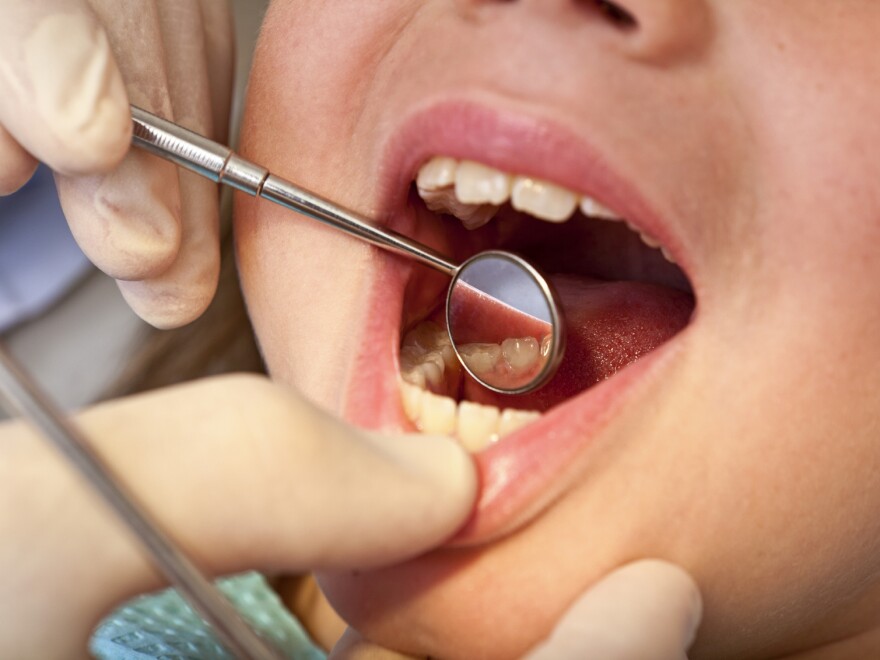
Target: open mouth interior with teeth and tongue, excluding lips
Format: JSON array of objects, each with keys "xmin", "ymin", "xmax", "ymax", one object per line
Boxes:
[{"xmin": 399, "ymin": 156, "xmax": 695, "ymax": 453}]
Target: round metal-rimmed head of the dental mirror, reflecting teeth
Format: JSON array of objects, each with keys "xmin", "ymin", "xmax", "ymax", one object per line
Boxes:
[{"xmin": 446, "ymin": 251, "xmax": 565, "ymax": 394}]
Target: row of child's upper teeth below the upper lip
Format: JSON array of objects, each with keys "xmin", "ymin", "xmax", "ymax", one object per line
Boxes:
[{"xmin": 416, "ymin": 156, "xmax": 672, "ymax": 261}]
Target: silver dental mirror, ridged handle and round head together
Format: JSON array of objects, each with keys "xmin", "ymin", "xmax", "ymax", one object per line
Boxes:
[{"xmin": 131, "ymin": 106, "xmax": 565, "ymax": 394}]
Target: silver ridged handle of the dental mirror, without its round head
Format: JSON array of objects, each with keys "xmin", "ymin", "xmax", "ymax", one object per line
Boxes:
[{"xmin": 131, "ymin": 106, "xmax": 458, "ymax": 277}]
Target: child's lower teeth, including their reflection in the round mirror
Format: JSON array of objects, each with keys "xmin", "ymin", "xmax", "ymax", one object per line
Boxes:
[{"xmin": 400, "ymin": 322, "xmax": 544, "ymax": 453}]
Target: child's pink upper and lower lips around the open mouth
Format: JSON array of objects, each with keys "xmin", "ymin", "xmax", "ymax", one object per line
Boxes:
[{"xmin": 342, "ymin": 102, "xmax": 692, "ymax": 545}]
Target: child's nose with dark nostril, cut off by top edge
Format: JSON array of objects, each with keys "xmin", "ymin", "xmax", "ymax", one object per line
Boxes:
[{"xmin": 457, "ymin": 0, "xmax": 711, "ymax": 63}]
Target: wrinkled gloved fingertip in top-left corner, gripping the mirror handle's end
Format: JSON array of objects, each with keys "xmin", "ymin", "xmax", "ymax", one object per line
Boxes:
[{"xmin": 0, "ymin": 0, "xmax": 131, "ymax": 174}]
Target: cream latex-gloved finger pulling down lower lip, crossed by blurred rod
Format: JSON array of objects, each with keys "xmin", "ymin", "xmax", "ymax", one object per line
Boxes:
[{"xmin": 0, "ymin": 376, "xmax": 477, "ymax": 659}]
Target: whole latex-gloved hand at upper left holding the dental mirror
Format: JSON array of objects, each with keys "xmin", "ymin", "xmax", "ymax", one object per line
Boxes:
[{"xmin": 0, "ymin": 0, "xmax": 233, "ymax": 327}]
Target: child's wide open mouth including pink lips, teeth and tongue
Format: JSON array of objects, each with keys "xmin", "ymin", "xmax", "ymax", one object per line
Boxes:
[{"xmin": 334, "ymin": 99, "xmax": 699, "ymax": 546}]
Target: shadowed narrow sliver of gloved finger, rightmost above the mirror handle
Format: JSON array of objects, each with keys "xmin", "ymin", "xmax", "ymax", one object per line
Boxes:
[{"xmin": 199, "ymin": 0, "xmax": 235, "ymax": 144}]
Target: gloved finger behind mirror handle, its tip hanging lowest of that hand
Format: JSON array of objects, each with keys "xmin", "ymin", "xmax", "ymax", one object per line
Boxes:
[{"xmin": 119, "ymin": 0, "xmax": 220, "ymax": 328}]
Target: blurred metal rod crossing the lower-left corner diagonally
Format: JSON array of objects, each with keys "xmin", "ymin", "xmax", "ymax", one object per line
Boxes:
[{"xmin": 0, "ymin": 343, "xmax": 282, "ymax": 660}]
